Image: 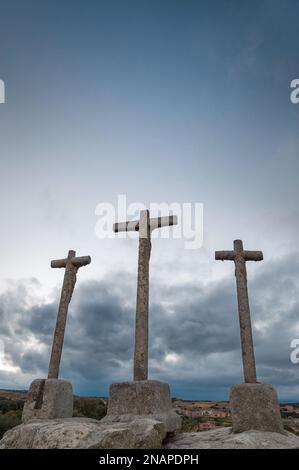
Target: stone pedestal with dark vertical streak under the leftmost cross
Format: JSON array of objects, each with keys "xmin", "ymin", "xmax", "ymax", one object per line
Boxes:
[{"xmin": 22, "ymin": 379, "xmax": 73, "ymax": 423}]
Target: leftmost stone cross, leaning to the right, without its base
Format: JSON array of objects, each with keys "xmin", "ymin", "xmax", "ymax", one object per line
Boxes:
[{"xmin": 48, "ymin": 250, "xmax": 91, "ymax": 379}]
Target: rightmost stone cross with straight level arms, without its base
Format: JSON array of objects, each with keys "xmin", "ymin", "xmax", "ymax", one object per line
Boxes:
[{"xmin": 215, "ymin": 240, "xmax": 263, "ymax": 383}]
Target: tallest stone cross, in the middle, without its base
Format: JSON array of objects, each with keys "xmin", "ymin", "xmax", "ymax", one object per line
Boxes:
[{"xmin": 113, "ymin": 210, "xmax": 177, "ymax": 380}]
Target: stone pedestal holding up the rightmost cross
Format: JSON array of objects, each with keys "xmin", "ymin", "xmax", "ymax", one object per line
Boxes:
[{"xmin": 230, "ymin": 383, "xmax": 284, "ymax": 433}]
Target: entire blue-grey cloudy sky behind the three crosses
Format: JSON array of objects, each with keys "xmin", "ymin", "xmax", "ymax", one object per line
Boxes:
[{"xmin": 0, "ymin": 0, "xmax": 299, "ymax": 401}]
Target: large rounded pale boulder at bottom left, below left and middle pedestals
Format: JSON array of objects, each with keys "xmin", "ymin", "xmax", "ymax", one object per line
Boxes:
[{"xmin": 0, "ymin": 418, "xmax": 166, "ymax": 449}]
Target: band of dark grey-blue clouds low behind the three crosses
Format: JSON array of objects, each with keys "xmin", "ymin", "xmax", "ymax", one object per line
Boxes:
[{"xmin": 0, "ymin": 254, "xmax": 299, "ymax": 398}]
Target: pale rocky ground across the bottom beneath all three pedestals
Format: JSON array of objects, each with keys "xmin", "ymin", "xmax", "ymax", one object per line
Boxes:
[{"xmin": 0, "ymin": 418, "xmax": 299, "ymax": 449}]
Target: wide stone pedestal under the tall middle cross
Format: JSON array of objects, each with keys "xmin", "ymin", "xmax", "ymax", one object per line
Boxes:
[{"xmin": 101, "ymin": 380, "xmax": 181, "ymax": 433}]
